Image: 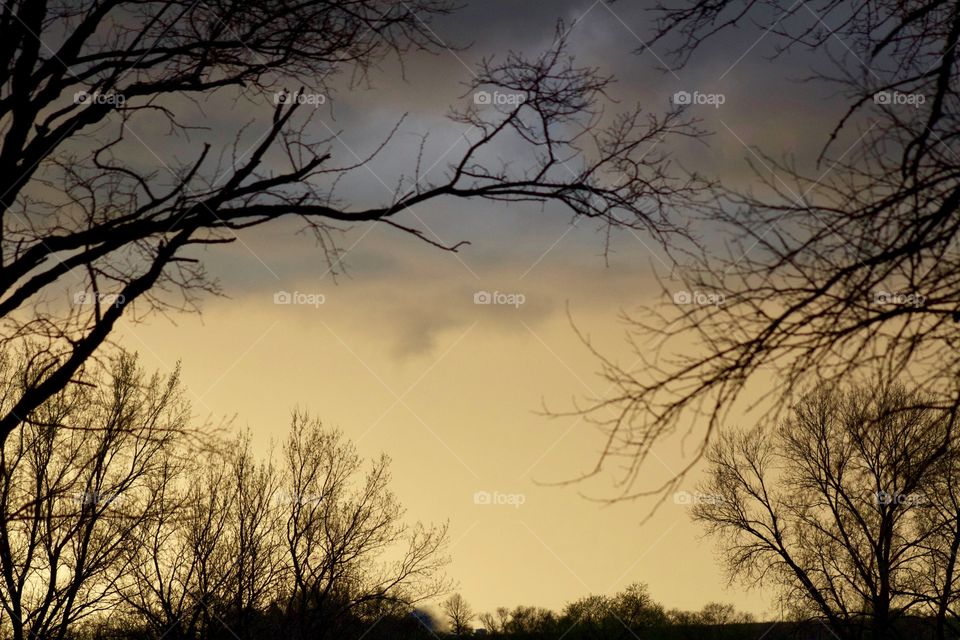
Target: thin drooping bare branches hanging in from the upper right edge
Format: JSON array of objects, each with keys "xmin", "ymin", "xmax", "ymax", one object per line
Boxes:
[{"xmin": 568, "ymin": 0, "xmax": 960, "ymax": 498}]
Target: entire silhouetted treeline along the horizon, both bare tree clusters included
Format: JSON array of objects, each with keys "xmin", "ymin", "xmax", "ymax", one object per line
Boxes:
[{"xmin": 9, "ymin": 353, "xmax": 960, "ymax": 640}]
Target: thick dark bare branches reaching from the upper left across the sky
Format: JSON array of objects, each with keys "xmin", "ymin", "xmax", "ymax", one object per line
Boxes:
[{"xmin": 0, "ymin": 0, "xmax": 697, "ymax": 441}]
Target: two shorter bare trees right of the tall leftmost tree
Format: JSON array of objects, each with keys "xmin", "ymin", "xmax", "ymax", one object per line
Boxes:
[{"xmin": 118, "ymin": 413, "xmax": 446, "ymax": 640}]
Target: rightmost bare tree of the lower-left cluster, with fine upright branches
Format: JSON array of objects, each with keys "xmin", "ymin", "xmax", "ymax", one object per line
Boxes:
[{"xmin": 281, "ymin": 413, "xmax": 447, "ymax": 637}]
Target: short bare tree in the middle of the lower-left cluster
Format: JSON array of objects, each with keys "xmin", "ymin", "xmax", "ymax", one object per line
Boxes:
[{"xmin": 118, "ymin": 434, "xmax": 285, "ymax": 639}]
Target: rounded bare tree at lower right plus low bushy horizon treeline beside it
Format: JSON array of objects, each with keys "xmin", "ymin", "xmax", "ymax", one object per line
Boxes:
[{"xmin": 428, "ymin": 377, "xmax": 960, "ymax": 640}]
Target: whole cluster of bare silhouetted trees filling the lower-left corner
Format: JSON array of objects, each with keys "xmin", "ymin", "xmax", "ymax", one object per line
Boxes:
[{"xmin": 0, "ymin": 355, "xmax": 447, "ymax": 640}]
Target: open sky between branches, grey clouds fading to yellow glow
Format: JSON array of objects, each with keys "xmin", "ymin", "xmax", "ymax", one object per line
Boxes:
[{"xmin": 107, "ymin": 0, "xmax": 848, "ymax": 614}]
